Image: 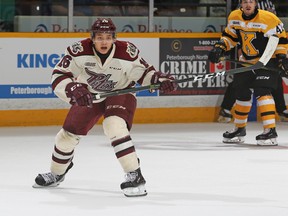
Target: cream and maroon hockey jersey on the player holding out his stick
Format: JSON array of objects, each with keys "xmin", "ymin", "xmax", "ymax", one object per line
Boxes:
[{"xmin": 52, "ymin": 38, "xmax": 155, "ymax": 103}]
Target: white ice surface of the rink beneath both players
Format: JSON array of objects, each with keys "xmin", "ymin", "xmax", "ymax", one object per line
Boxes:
[{"xmin": 0, "ymin": 122, "xmax": 288, "ymax": 216}]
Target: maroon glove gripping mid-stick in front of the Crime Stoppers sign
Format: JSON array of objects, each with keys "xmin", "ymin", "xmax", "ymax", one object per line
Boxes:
[{"xmin": 151, "ymin": 71, "xmax": 178, "ymax": 93}]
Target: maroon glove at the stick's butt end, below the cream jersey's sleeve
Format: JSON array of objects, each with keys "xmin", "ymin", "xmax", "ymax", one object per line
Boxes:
[{"xmin": 65, "ymin": 82, "xmax": 93, "ymax": 108}]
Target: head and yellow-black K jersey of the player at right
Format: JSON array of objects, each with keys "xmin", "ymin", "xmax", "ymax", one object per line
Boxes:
[{"xmin": 221, "ymin": 3, "xmax": 288, "ymax": 62}]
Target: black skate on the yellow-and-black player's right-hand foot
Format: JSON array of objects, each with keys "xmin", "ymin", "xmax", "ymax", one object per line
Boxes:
[{"xmin": 256, "ymin": 128, "xmax": 278, "ymax": 146}]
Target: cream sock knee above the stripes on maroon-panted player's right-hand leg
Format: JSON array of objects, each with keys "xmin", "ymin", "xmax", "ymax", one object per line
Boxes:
[{"xmin": 103, "ymin": 116, "xmax": 129, "ymax": 139}]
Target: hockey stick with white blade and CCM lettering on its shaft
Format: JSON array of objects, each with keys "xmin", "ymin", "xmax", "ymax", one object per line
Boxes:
[{"xmin": 93, "ymin": 35, "xmax": 279, "ymax": 100}]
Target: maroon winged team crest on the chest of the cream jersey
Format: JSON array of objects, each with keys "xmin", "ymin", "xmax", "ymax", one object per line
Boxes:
[{"xmin": 85, "ymin": 68, "xmax": 117, "ymax": 91}]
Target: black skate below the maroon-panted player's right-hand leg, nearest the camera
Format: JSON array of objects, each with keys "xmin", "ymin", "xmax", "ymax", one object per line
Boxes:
[{"xmin": 120, "ymin": 168, "xmax": 147, "ymax": 197}]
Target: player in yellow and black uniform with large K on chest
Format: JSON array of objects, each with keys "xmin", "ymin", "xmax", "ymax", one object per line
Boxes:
[{"xmin": 209, "ymin": 0, "xmax": 288, "ymax": 145}]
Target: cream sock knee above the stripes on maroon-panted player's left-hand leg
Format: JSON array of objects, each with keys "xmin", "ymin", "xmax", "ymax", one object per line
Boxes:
[{"xmin": 55, "ymin": 128, "xmax": 80, "ymax": 152}]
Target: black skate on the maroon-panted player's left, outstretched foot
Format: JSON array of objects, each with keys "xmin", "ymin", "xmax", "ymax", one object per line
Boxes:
[{"xmin": 33, "ymin": 162, "xmax": 73, "ymax": 188}]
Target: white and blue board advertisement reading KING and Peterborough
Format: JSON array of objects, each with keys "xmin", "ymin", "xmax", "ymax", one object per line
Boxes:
[{"xmin": 0, "ymin": 38, "xmax": 159, "ymax": 99}]
